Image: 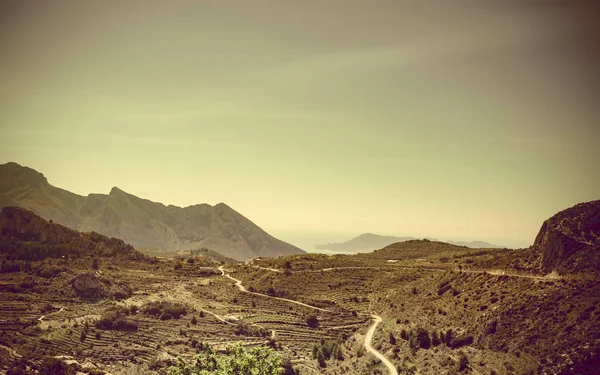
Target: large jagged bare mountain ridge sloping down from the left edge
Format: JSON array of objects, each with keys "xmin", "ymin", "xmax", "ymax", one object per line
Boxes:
[{"xmin": 0, "ymin": 163, "xmax": 304, "ymax": 260}]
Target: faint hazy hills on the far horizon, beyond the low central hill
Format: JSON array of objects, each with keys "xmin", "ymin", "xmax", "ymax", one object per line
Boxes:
[{"xmin": 315, "ymin": 233, "xmax": 501, "ymax": 253}]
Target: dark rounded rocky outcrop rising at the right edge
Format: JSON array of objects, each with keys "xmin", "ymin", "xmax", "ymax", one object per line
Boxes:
[{"xmin": 533, "ymin": 200, "xmax": 600, "ymax": 274}]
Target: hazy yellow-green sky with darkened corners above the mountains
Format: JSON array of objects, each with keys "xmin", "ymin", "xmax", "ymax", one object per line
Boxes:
[{"xmin": 0, "ymin": 0, "xmax": 600, "ymax": 248}]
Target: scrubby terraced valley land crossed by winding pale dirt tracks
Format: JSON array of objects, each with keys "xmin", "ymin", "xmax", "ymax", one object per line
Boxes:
[{"xmin": 0, "ymin": 203, "xmax": 600, "ymax": 375}]
